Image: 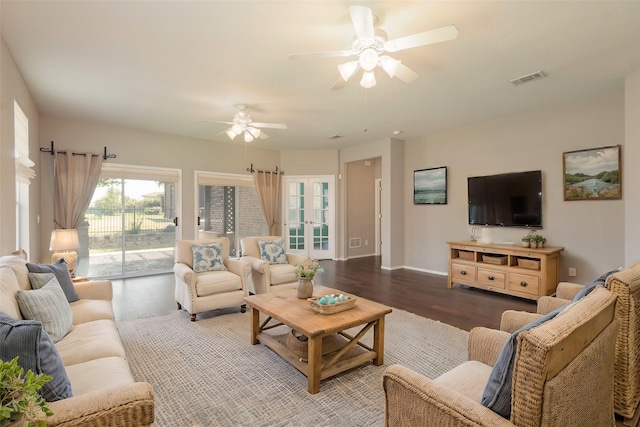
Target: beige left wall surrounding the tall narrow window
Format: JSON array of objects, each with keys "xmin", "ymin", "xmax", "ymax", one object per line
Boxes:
[{"xmin": 0, "ymin": 37, "xmax": 41, "ymax": 258}]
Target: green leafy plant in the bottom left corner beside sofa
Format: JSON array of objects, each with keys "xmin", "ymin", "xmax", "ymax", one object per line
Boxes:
[{"xmin": 0, "ymin": 357, "xmax": 53, "ymax": 427}]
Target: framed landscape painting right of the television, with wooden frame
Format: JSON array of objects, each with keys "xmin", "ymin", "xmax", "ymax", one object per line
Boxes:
[{"xmin": 562, "ymin": 145, "xmax": 622, "ymax": 200}]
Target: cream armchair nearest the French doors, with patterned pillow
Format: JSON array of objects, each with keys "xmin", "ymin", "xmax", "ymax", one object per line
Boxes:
[{"xmin": 240, "ymin": 236, "xmax": 309, "ymax": 294}]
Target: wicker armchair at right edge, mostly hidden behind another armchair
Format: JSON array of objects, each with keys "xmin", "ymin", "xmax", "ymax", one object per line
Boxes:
[{"xmin": 500, "ymin": 261, "xmax": 640, "ymax": 426}]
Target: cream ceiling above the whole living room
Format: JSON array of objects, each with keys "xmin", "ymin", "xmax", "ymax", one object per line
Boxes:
[{"xmin": 0, "ymin": 0, "xmax": 640, "ymax": 149}]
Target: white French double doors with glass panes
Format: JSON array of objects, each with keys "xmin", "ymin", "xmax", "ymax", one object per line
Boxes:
[{"xmin": 283, "ymin": 175, "xmax": 335, "ymax": 259}]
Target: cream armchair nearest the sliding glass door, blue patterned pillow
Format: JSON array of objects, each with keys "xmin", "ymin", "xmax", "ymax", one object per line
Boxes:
[{"xmin": 173, "ymin": 237, "xmax": 250, "ymax": 322}]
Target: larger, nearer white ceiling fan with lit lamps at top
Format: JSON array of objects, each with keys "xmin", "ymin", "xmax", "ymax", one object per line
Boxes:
[{"xmin": 289, "ymin": 6, "xmax": 458, "ymax": 90}]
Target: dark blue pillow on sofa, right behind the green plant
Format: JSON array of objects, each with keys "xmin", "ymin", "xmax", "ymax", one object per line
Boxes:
[{"xmin": 0, "ymin": 312, "xmax": 73, "ymax": 402}]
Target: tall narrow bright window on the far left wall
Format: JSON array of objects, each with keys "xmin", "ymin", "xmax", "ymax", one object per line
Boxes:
[{"xmin": 13, "ymin": 100, "xmax": 36, "ymax": 254}]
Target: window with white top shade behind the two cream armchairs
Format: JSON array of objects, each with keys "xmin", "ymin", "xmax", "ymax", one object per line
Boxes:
[{"xmin": 196, "ymin": 172, "xmax": 269, "ymax": 257}]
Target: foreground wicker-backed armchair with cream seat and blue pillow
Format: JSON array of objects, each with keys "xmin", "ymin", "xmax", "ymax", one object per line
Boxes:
[{"xmin": 383, "ymin": 286, "xmax": 618, "ymax": 427}]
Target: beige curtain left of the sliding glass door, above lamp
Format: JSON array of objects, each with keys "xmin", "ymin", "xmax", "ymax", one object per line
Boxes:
[{"xmin": 53, "ymin": 151, "xmax": 102, "ymax": 229}]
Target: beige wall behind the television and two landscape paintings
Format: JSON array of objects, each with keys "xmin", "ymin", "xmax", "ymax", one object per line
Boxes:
[{"xmin": 404, "ymin": 90, "xmax": 624, "ymax": 283}]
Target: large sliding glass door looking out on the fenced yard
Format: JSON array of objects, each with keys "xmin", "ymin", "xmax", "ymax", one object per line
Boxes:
[{"xmin": 78, "ymin": 167, "xmax": 178, "ymax": 278}]
